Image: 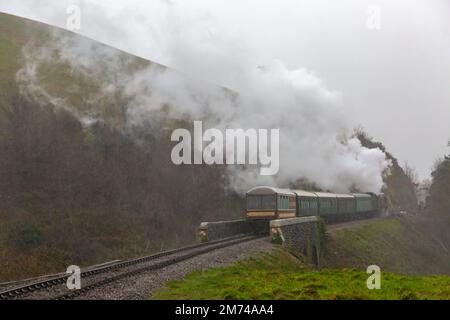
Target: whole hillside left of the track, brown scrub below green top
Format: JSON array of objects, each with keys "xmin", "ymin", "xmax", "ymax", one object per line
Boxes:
[{"xmin": 0, "ymin": 14, "xmax": 240, "ymax": 281}]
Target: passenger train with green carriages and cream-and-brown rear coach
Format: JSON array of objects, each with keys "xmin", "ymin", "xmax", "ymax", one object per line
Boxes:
[{"xmin": 246, "ymin": 186, "xmax": 387, "ymax": 223}]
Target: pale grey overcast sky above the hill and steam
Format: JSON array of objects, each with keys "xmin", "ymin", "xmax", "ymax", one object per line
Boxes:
[{"xmin": 0, "ymin": 0, "xmax": 450, "ymax": 178}]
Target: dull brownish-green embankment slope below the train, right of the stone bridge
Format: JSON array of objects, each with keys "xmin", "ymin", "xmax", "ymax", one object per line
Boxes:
[{"xmin": 322, "ymin": 217, "xmax": 450, "ymax": 275}]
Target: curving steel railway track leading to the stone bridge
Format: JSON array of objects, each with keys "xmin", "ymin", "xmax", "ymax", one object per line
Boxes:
[{"xmin": 0, "ymin": 234, "xmax": 262, "ymax": 300}]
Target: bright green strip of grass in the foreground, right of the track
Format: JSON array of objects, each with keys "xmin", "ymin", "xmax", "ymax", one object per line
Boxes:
[{"xmin": 152, "ymin": 250, "xmax": 450, "ymax": 300}]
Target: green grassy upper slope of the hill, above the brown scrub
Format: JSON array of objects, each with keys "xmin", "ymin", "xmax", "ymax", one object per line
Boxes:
[{"xmin": 0, "ymin": 13, "xmax": 154, "ymax": 126}]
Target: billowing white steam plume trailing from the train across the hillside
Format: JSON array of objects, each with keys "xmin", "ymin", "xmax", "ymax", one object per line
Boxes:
[{"xmin": 18, "ymin": 3, "xmax": 389, "ymax": 192}]
